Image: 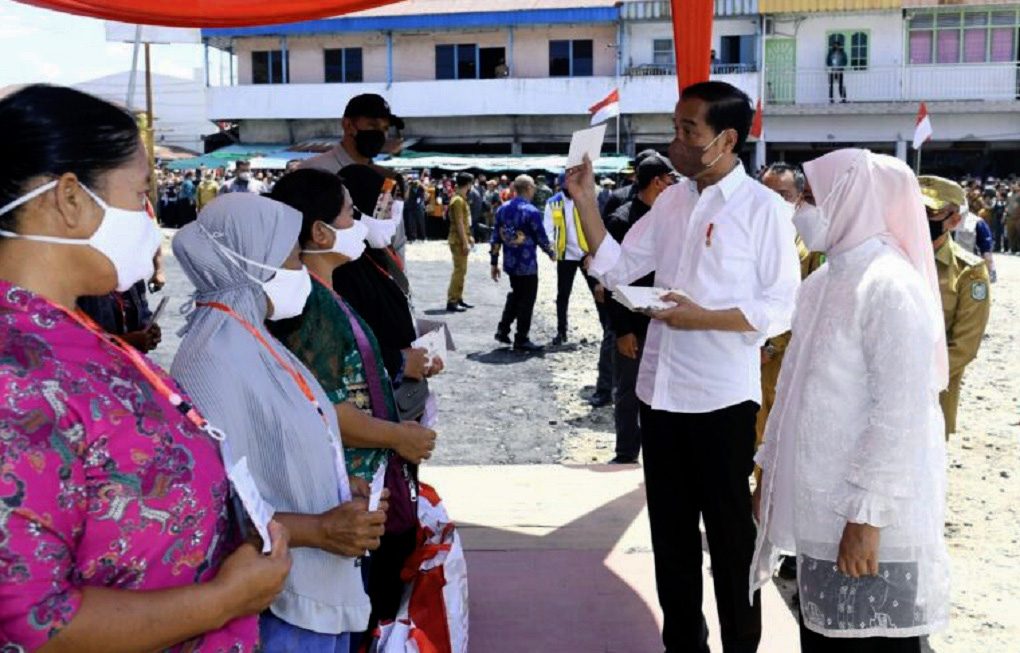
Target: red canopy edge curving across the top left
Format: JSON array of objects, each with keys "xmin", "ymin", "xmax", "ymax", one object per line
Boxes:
[{"xmin": 18, "ymin": 0, "xmax": 397, "ymax": 28}]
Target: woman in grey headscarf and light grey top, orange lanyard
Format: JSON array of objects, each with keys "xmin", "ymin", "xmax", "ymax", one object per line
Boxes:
[{"xmin": 171, "ymin": 193, "xmax": 386, "ymax": 653}]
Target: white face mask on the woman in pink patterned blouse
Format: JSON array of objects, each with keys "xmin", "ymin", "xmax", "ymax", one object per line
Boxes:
[{"xmin": 0, "ymin": 182, "xmax": 163, "ymax": 293}]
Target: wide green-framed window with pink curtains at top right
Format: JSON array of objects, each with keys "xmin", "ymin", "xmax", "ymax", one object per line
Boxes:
[{"xmin": 907, "ymin": 9, "xmax": 1020, "ymax": 65}]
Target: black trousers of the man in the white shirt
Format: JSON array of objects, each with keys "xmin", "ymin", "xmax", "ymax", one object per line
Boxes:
[{"xmin": 641, "ymin": 401, "xmax": 762, "ymax": 653}]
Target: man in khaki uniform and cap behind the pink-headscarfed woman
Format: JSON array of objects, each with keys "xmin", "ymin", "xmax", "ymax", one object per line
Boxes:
[{"xmin": 918, "ymin": 175, "xmax": 991, "ymax": 438}]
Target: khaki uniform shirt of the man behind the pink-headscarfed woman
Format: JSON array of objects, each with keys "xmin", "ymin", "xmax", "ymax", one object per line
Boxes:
[{"xmin": 935, "ymin": 239, "xmax": 991, "ymax": 438}]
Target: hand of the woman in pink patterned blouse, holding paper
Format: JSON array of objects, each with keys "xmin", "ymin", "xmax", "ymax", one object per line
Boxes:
[{"xmin": 212, "ymin": 521, "xmax": 291, "ymax": 621}]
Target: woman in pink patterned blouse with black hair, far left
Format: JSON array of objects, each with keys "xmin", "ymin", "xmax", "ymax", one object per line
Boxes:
[{"xmin": 0, "ymin": 86, "xmax": 290, "ymax": 653}]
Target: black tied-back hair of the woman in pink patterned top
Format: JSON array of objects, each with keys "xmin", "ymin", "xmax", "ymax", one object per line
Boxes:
[{"xmin": 0, "ymin": 84, "xmax": 141, "ymax": 231}]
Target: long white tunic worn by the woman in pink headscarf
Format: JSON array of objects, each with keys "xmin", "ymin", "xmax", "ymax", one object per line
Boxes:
[{"xmin": 751, "ymin": 237, "xmax": 949, "ymax": 638}]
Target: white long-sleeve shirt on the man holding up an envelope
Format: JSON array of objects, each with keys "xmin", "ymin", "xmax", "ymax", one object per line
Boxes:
[{"xmin": 591, "ymin": 165, "xmax": 801, "ymax": 413}]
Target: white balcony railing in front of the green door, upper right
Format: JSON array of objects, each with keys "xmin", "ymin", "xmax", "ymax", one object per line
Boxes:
[{"xmin": 765, "ymin": 61, "xmax": 1020, "ymax": 104}]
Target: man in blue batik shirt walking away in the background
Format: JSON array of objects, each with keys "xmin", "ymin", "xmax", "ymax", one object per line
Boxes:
[{"xmin": 490, "ymin": 174, "xmax": 556, "ymax": 352}]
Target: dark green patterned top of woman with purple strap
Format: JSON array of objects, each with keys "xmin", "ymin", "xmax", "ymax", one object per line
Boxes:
[{"xmin": 269, "ymin": 281, "xmax": 397, "ymax": 481}]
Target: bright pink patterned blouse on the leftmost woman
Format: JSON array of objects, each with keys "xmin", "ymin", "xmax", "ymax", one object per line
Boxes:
[{"xmin": 0, "ymin": 281, "xmax": 258, "ymax": 652}]
